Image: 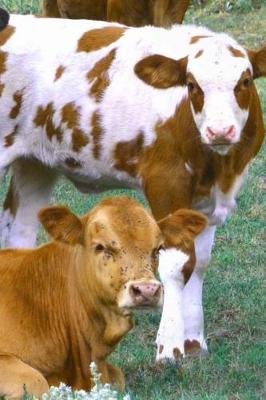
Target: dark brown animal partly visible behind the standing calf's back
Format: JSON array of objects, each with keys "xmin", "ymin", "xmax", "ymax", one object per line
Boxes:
[{"xmin": 43, "ymin": 0, "xmax": 190, "ymax": 27}]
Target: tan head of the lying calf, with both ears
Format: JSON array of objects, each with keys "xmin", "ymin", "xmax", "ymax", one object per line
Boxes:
[{"xmin": 39, "ymin": 197, "xmax": 206, "ymax": 313}]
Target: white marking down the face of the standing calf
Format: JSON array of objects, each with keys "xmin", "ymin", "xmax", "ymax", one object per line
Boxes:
[{"xmin": 188, "ymin": 34, "xmax": 252, "ymax": 154}]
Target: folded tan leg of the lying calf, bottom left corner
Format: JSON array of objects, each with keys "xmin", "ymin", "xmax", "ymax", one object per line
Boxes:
[{"xmin": 0, "ymin": 354, "xmax": 49, "ymax": 399}]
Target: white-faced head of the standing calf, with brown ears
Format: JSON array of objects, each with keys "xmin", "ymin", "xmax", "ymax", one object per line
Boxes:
[{"xmin": 135, "ymin": 32, "xmax": 266, "ymax": 154}]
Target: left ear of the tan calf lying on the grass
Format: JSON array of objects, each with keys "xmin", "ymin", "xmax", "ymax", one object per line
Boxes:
[{"xmin": 38, "ymin": 206, "xmax": 83, "ymax": 245}]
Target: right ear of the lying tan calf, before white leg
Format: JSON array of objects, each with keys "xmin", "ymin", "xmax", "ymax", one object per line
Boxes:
[{"xmin": 158, "ymin": 209, "xmax": 208, "ymax": 250}]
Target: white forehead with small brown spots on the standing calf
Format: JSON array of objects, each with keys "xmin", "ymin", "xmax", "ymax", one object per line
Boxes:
[{"xmin": 188, "ymin": 34, "xmax": 252, "ymax": 88}]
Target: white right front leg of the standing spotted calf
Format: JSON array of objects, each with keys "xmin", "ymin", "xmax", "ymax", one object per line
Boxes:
[{"xmin": 183, "ymin": 226, "xmax": 216, "ymax": 354}]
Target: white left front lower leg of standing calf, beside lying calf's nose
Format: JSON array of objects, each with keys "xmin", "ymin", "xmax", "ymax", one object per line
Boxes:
[{"xmin": 156, "ymin": 248, "xmax": 188, "ymax": 362}]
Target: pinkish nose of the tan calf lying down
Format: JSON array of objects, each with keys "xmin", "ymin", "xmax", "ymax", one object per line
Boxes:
[{"xmin": 129, "ymin": 282, "xmax": 161, "ymax": 305}]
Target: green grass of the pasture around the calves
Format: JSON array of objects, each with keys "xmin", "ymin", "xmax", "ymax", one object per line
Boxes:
[{"xmin": 0, "ymin": 0, "xmax": 266, "ymax": 400}]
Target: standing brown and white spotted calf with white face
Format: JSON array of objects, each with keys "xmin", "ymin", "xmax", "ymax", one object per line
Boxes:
[{"xmin": 0, "ymin": 16, "xmax": 266, "ymax": 360}]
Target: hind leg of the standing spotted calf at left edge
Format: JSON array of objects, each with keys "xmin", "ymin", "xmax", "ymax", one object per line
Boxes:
[{"xmin": 0, "ymin": 159, "xmax": 56, "ymax": 247}]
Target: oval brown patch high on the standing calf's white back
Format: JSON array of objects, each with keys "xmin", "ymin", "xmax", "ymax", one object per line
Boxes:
[{"xmin": 77, "ymin": 26, "xmax": 125, "ymax": 52}]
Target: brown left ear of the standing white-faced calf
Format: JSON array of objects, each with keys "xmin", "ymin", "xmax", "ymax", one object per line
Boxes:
[{"xmin": 134, "ymin": 54, "xmax": 187, "ymax": 89}]
